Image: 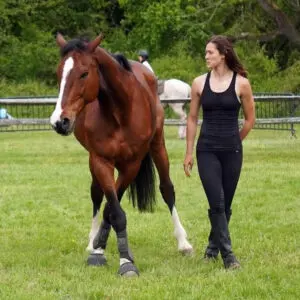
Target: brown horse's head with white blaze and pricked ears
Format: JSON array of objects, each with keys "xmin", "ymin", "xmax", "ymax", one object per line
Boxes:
[{"xmin": 50, "ymin": 34, "xmax": 102, "ymax": 135}]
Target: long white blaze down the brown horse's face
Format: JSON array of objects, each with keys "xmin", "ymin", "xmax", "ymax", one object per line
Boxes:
[{"xmin": 50, "ymin": 57, "xmax": 74, "ymax": 126}]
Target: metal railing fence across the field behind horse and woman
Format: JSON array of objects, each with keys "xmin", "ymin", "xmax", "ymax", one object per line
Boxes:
[{"xmin": 0, "ymin": 94, "xmax": 300, "ymax": 136}]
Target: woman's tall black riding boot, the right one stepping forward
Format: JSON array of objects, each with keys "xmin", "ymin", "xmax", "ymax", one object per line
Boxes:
[{"xmin": 210, "ymin": 212, "xmax": 240, "ymax": 269}]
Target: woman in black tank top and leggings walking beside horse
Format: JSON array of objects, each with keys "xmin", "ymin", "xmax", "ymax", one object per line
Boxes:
[{"xmin": 184, "ymin": 36, "xmax": 255, "ymax": 268}]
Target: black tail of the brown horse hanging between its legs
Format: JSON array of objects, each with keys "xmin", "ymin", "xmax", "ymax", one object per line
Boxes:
[{"xmin": 128, "ymin": 153, "xmax": 156, "ymax": 212}]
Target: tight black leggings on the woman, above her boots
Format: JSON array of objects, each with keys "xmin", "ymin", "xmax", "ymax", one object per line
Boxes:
[{"xmin": 197, "ymin": 150, "xmax": 243, "ymax": 213}]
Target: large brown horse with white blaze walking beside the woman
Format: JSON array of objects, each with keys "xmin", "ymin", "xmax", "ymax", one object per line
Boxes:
[{"xmin": 50, "ymin": 33, "xmax": 193, "ymax": 276}]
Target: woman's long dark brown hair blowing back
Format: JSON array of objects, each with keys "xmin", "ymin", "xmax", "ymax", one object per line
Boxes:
[{"xmin": 207, "ymin": 35, "xmax": 247, "ymax": 78}]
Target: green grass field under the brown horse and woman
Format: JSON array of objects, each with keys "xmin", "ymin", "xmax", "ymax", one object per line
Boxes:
[{"xmin": 0, "ymin": 128, "xmax": 300, "ymax": 300}]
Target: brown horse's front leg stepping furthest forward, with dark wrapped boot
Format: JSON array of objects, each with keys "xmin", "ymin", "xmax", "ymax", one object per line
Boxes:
[{"xmin": 88, "ymin": 156, "xmax": 138, "ymax": 276}]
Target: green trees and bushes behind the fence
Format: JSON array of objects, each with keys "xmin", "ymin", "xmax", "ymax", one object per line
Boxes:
[{"xmin": 0, "ymin": 0, "xmax": 300, "ymax": 92}]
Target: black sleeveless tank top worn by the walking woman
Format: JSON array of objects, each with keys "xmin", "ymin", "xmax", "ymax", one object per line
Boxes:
[{"xmin": 197, "ymin": 72, "xmax": 242, "ymax": 151}]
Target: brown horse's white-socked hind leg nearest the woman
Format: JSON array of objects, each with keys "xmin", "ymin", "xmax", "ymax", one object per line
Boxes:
[{"xmin": 151, "ymin": 132, "xmax": 193, "ymax": 254}]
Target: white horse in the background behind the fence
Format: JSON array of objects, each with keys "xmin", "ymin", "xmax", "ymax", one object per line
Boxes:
[{"xmin": 158, "ymin": 79, "xmax": 191, "ymax": 139}]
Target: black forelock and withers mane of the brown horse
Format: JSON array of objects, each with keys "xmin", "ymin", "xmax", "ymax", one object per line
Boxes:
[{"xmin": 60, "ymin": 38, "xmax": 132, "ymax": 72}]
